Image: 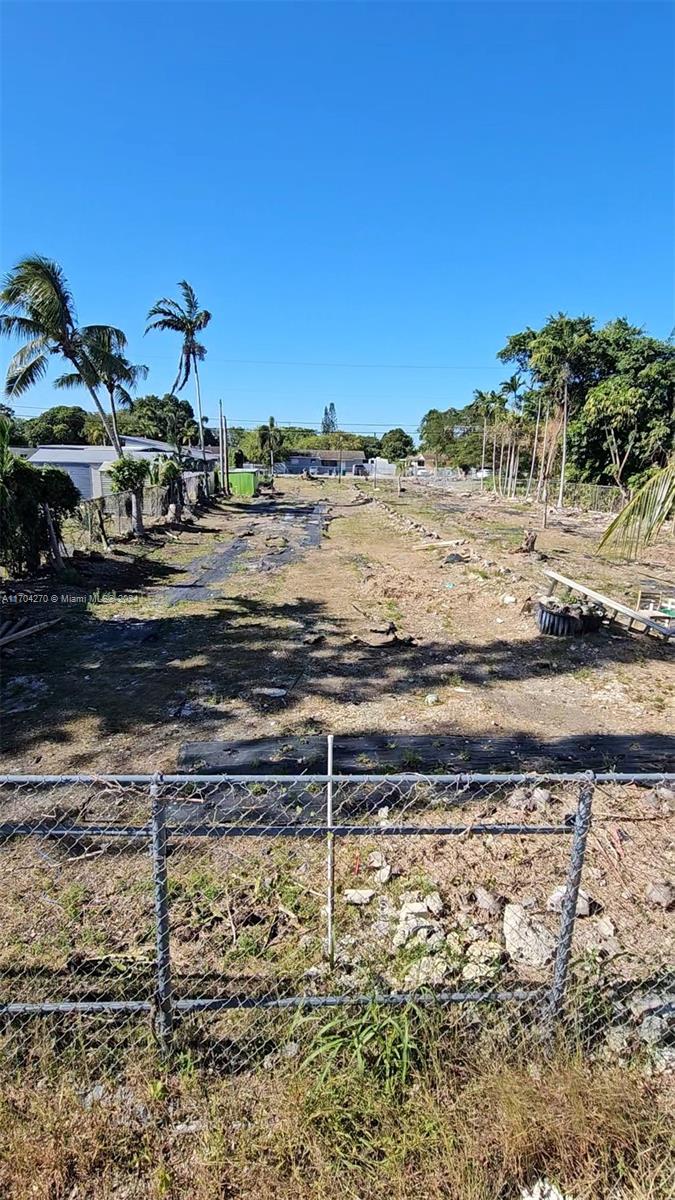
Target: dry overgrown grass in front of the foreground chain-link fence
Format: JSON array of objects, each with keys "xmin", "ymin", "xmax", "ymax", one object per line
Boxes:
[{"xmin": 0, "ymin": 1006, "xmax": 673, "ymax": 1200}]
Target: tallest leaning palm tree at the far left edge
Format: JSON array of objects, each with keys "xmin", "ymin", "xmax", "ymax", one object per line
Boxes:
[{"xmin": 0, "ymin": 254, "xmax": 124, "ymax": 457}]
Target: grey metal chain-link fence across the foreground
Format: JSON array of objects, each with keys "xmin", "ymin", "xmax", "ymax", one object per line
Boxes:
[{"xmin": 0, "ymin": 753, "xmax": 675, "ymax": 1070}]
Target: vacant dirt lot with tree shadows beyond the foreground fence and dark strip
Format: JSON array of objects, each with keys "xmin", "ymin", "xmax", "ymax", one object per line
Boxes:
[{"xmin": 2, "ymin": 479, "xmax": 675, "ymax": 772}]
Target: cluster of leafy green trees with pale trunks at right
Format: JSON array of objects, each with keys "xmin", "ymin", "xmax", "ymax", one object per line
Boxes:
[{"xmin": 420, "ymin": 313, "xmax": 675, "ymax": 504}]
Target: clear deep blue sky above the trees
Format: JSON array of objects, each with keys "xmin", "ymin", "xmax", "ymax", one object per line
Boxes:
[{"xmin": 0, "ymin": 0, "xmax": 674, "ymax": 432}]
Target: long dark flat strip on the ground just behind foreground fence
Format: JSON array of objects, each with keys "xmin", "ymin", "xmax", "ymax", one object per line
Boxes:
[{"xmin": 178, "ymin": 733, "xmax": 675, "ymax": 775}]
